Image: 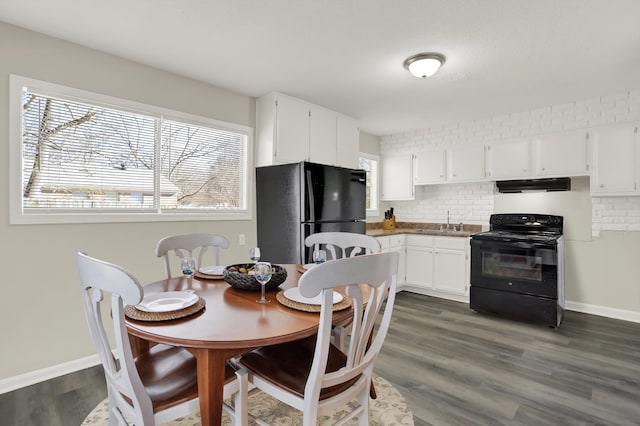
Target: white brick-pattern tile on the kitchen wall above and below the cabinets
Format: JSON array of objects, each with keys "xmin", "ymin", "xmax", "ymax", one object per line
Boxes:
[{"xmin": 380, "ymin": 90, "xmax": 640, "ymax": 236}]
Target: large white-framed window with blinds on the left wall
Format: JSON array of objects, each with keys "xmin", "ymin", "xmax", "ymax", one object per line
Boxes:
[{"xmin": 11, "ymin": 76, "xmax": 252, "ymax": 223}]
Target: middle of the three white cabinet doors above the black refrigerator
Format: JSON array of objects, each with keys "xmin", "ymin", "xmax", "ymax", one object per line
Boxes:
[{"xmin": 309, "ymin": 105, "xmax": 337, "ymax": 165}]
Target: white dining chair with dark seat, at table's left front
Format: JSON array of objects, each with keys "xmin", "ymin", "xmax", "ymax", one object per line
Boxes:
[{"xmin": 77, "ymin": 253, "xmax": 248, "ymax": 426}]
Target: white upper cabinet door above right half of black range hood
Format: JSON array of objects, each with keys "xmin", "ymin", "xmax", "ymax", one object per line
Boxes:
[{"xmin": 534, "ymin": 129, "xmax": 589, "ymax": 177}]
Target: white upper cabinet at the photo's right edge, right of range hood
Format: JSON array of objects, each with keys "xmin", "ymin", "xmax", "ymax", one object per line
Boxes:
[{"xmin": 590, "ymin": 124, "xmax": 640, "ymax": 196}]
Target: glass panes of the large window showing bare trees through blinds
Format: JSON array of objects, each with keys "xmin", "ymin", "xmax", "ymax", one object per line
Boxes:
[{"xmin": 22, "ymin": 91, "xmax": 246, "ymax": 211}]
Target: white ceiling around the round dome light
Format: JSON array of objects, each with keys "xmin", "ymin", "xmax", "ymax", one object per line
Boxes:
[{"xmin": 0, "ymin": 0, "xmax": 640, "ymax": 135}]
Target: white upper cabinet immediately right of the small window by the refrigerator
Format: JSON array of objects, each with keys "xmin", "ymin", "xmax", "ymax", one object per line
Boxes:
[{"xmin": 382, "ymin": 154, "xmax": 415, "ymax": 201}]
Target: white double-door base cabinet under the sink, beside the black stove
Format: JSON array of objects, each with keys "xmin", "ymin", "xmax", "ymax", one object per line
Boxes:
[{"xmin": 405, "ymin": 235, "xmax": 469, "ymax": 301}]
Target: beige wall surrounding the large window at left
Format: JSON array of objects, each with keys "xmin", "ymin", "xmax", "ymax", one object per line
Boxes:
[{"xmin": 0, "ymin": 22, "xmax": 256, "ymax": 380}]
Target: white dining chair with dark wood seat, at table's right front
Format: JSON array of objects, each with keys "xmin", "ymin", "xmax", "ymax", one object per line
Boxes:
[{"xmin": 239, "ymin": 252, "xmax": 399, "ymax": 426}]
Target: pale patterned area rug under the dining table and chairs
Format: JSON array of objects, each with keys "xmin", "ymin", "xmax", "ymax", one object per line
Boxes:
[{"xmin": 82, "ymin": 376, "xmax": 413, "ymax": 426}]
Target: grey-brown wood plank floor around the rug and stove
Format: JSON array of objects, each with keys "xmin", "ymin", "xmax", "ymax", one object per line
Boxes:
[{"xmin": 0, "ymin": 292, "xmax": 640, "ymax": 426}]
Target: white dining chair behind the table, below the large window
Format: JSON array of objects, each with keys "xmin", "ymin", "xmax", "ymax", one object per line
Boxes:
[{"xmin": 156, "ymin": 234, "xmax": 229, "ymax": 278}]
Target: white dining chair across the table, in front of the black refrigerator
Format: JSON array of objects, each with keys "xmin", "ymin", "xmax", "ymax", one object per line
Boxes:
[{"xmin": 304, "ymin": 232, "xmax": 381, "ymax": 350}]
